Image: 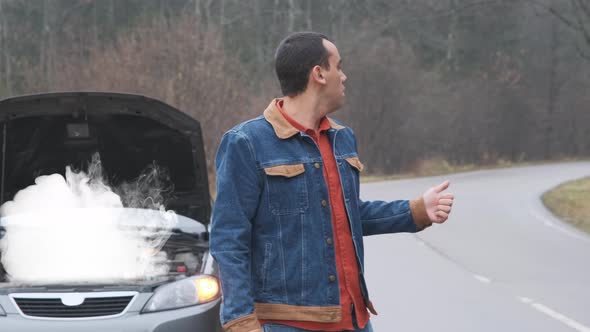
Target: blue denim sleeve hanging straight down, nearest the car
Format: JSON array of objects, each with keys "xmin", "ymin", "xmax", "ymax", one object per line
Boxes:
[{"xmin": 210, "ymin": 131, "xmax": 262, "ymax": 332}]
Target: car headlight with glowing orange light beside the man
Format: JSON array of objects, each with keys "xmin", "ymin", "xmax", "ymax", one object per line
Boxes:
[{"xmin": 141, "ymin": 275, "xmax": 219, "ymax": 313}]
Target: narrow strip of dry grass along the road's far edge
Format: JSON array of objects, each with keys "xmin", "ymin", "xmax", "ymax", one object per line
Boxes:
[{"xmin": 361, "ymin": 158, "xmax": 581, "ymax": 183}]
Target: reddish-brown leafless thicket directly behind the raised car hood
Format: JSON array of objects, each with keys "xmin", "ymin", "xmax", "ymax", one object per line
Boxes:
[{"xmin": 27, "ymin": 17, "xmax": 255, "ymax": 178}]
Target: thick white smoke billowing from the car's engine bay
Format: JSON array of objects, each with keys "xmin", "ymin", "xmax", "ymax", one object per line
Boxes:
[{"xmin": 0, "ymin": 155, "xmax": 177, "ymax": 284}]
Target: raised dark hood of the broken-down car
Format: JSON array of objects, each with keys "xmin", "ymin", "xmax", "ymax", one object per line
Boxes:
[{"xmin": 0, "ymin": 92, "xmax": 211, "ymax": 224}]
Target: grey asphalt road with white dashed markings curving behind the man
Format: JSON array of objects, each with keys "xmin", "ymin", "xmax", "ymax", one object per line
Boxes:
[{"xmin": 361, "ymin": 162, "xmax": 590, "ymax": 332}]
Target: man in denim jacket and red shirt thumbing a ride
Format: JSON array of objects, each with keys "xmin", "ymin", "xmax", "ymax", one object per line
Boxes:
[{"xmin": 211, "ymin": 32, "xmax": 453, "ymax": 332}]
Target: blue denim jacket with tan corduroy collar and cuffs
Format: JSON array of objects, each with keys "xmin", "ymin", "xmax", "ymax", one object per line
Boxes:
[{"xmin": 210, "ymin": 100, "xmax": 431, "ymax": 331}]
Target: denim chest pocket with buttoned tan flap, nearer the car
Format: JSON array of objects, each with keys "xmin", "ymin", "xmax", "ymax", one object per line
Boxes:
[{"xmin": 264, "ymin": 164, "xmax": 308, "ymax": 215}]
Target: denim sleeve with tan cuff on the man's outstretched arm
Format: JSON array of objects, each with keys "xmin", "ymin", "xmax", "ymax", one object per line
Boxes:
[{"xmin": 359, "ymin": 197, "xmax": 432, "ymax": 235}]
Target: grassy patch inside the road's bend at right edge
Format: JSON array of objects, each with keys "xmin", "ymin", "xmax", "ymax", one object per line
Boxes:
[{"xmin": 541, "ymin": 177, "xmax": 590, "ymax": 234}]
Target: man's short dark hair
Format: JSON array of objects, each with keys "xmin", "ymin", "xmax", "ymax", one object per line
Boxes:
[{"xmin": 275, "ymin": 32, "xmax": 331, "ymax": 97}]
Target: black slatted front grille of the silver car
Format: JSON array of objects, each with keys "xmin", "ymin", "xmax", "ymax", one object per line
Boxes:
[{"xmin": 12, "ymin": 294, "xmax": 134, "ymax": 319}]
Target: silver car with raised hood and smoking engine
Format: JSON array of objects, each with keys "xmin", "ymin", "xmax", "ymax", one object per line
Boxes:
[{"xmin": 0, "ymin": 92, "xmax": 222, "ymax": 332}]
